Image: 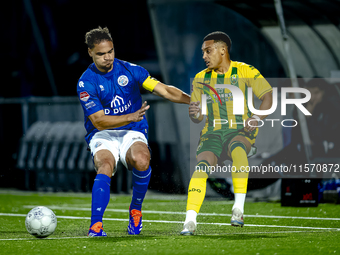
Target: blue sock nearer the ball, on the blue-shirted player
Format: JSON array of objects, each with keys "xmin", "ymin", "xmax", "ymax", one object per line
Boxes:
[{"xmin": 90, "ymin": 174, "xmax": 111, "ymax": 227}]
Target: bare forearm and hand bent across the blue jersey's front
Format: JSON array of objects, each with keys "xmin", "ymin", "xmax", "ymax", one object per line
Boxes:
[{"xmin": 89, "ymin": 101, "xmax": 150, "ymax": 130}]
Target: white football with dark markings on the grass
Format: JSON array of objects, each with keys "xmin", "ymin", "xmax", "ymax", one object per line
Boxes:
[{"xmin": 25, "ymin": 206, "xmax": 57, "ymax": 238}]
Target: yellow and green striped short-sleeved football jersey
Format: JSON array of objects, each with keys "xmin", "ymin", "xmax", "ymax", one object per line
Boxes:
[{"xmin": 191, "ymin": 61, "xmax": 272, "ymax": 135}]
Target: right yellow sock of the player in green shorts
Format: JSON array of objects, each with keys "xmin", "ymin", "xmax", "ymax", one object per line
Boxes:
[{"xmin": 230, "ymin": 141, "xmax": 249, "ymax": 193}]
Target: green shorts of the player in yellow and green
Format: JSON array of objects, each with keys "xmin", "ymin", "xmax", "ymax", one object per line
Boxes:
[{"xmin": 196, "ymin": 130, "xmax": 258, "ymax": 159}]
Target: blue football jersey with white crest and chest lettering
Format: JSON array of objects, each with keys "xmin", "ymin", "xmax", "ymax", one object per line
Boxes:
[{"xmin": 77, "ymin": 58, "xmax": 149, "ymax": 144}]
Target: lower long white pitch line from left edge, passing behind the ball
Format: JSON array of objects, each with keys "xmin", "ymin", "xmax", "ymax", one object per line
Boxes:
[{"xmin": 0, "ymin": 213, "xmax": 340, "ymax": 231}]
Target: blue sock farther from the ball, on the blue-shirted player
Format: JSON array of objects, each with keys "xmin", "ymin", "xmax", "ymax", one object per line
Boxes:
[{"xmin": 130, "ymin": 166, "xmax": 151, "ymax": 211}]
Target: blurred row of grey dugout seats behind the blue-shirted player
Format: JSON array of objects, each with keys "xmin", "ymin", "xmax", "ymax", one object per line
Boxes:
[{"xmin": 17, "ymin": 121, "xmax": 132, "ymax": 193}]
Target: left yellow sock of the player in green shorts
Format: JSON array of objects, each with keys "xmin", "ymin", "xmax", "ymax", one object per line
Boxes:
[{"xmin": 187, "ymin": 160, "xmax": 210, "ymax": 213}]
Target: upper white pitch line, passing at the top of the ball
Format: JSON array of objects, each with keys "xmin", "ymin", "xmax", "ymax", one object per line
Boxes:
[{"xmin": 23, "ymin": 205, "xmax": 340, "ymax": 221}]
